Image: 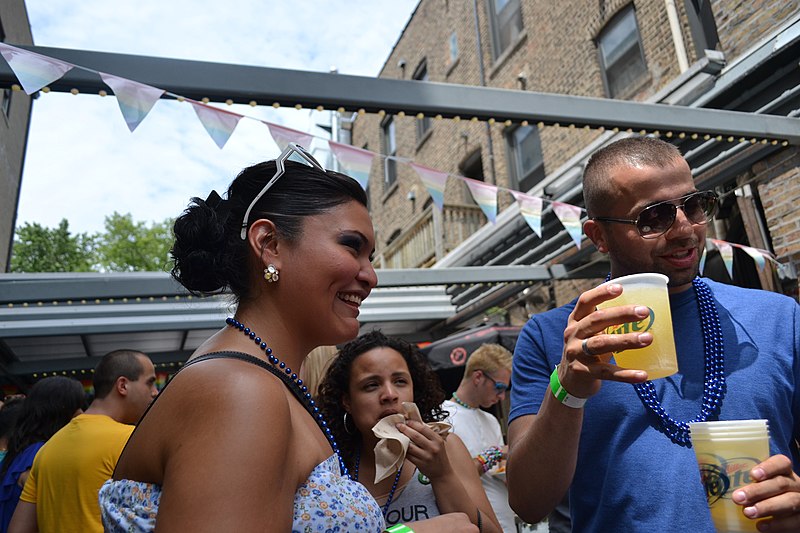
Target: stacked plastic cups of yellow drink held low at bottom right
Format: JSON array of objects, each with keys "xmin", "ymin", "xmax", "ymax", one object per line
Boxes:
[{"xmin": 689, "ymin": 420, "xmax": 769, "ymax": 532}]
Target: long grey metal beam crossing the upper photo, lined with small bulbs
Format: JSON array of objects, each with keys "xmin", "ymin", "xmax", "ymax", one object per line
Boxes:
[{"xmin": 0, "ymin": 46, "xmax": 800, "ymax": 144}]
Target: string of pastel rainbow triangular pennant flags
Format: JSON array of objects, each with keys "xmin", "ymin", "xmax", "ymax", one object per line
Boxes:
[{"xmin": 0, "ymin": 42, "xmax": 783, "ymax": 278}]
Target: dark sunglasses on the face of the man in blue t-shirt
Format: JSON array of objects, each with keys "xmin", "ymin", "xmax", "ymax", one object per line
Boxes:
[{"xmin": 591, "ymin": 191, "xmax": 719, "ymax": 239}]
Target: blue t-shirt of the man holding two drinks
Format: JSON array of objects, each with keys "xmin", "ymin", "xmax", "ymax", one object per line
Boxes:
[{"xmin": 509, "ymin": 279, "xmax": 800, "ymax": 533}]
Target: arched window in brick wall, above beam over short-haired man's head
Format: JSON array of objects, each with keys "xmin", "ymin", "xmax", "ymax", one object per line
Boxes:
[{"xmin": 598, "ymin": 6, "xmax": 647, "ymax": 98}]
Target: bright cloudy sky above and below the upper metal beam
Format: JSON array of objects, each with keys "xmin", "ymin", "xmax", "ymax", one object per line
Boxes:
[{"xmin": 17, "ymin": 0, "xmax": 417, "ymax": 233}]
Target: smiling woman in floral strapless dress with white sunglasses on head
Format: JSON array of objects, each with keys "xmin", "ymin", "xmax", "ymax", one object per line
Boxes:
[{"xmin": 100, "ymin": 144, "xmax": 478, "ymax": 532}]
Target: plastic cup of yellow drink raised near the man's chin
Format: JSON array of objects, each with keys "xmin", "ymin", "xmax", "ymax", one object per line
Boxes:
[{"xmin": 597, "ymin": 273, "xmax": 678, "ymax": 379}]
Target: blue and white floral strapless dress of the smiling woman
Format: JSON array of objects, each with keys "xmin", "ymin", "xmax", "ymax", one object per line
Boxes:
[{"xmin": 99, "ymin": 455, "xmax": 385, "ymax": 533}]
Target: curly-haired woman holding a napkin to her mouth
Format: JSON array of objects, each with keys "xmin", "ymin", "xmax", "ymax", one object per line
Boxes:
[{"xmin": 317, "ymin": 331, "xmax": 501, "ymax": 532}]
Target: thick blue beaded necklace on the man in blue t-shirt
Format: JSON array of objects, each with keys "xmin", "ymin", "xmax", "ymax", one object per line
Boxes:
[{"xmin": 609, "ymin": 274, "xmax": 726, "ymax": 448}]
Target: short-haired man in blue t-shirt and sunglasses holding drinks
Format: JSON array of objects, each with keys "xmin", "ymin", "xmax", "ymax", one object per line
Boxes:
[{"xmin": 508, "ymin": 137, "xmax": 800, "ymax": 533}]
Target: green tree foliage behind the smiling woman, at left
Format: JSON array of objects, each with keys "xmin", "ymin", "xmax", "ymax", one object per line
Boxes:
[{"xmin": 11, "ymin": 212, "xmax": 172, "ymax": 272}]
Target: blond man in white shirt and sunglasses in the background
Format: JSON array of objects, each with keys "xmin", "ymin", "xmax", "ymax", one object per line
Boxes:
[{"xmin": 442, "ymin": 344, "xmax": 517, "ymax": 533}]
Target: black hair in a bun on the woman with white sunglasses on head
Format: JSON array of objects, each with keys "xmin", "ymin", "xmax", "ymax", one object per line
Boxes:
[{"xmin": 170, "ymin": 161, "xmax": 367, "ymax": 301}]
